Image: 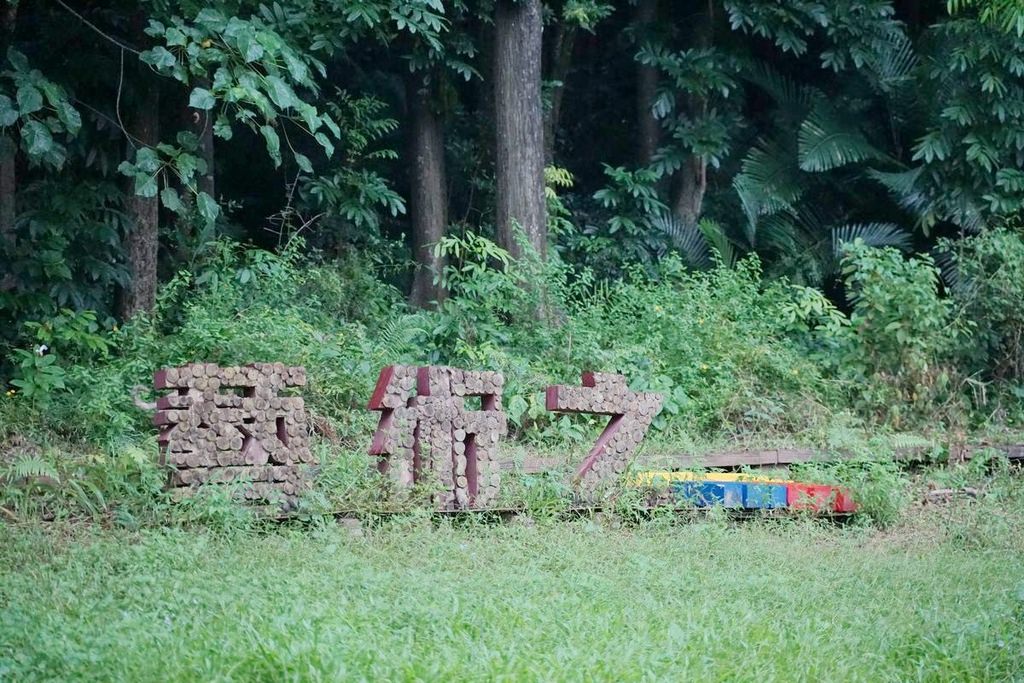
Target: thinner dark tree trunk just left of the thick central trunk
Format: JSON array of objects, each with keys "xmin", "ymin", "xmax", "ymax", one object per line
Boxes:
[{"xmin": 408, "ymin": 74, "xmax": 447, "ymax": 308}]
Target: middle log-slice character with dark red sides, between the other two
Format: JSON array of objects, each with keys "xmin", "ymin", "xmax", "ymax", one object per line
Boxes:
[{"xmin": 369, "ymin": 366, "xmax": 508, "ymax": 510}]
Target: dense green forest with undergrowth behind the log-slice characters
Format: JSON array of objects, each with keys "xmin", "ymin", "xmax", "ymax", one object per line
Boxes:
[{"xmin": 0, "ymin": 0, "xmax": 1024, "ymax": 475}]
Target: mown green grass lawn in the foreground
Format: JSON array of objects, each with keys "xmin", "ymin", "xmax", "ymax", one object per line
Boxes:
[{"xmin": 0, "ymin": 505, "xmax": 1024, "ymax": 681}]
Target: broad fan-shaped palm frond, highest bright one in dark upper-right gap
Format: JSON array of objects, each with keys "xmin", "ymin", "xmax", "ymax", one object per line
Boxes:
[{"xmin": 797, "ymin": 105, "xmax": 885, "ymax": 172}]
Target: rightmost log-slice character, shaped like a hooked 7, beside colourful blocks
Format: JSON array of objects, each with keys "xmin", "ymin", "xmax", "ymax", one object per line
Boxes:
[{"xmin": 547, "ymin": 372, "xmax": 662, "ymax": 493}]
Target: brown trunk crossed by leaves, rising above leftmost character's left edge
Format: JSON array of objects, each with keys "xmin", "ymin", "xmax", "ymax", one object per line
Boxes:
[{"xmin": 118, "ymin": 81, "xmax": 160, "ymax": 321}]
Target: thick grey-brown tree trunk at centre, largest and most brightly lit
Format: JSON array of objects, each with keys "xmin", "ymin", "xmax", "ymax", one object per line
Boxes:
[{"xmin": 495, "ymin": 0, "xmax": 548, "ymax": 259}]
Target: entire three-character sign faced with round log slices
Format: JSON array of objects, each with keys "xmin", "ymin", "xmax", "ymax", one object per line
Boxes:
[{"xmin": 154, "ymin": 364, "xmax": 662, "ymax": 510}]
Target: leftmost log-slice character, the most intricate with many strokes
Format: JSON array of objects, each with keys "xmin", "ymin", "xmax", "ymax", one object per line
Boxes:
[{"xmin": 153, "ymin": 364, "xmax": 313, "ymax": 509}]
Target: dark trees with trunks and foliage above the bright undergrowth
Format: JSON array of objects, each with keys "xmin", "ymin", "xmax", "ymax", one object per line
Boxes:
[{"xmin": 0, "ymin": 0, "xmax": 1024, "ymax": 374}]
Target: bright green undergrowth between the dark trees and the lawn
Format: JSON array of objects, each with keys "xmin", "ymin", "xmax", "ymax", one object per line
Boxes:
[{"xmin": 0, "ymin": 230, "xmax": 1024, "ymax": 525}]
